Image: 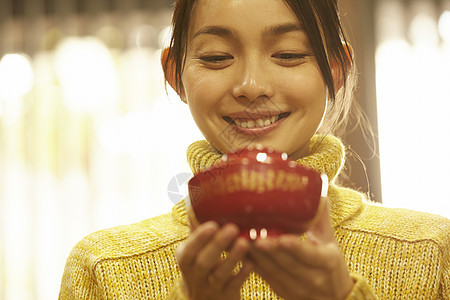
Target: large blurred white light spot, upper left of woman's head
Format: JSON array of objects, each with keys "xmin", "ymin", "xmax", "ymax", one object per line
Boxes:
[{"xmin": 55, "ymin": 37, "xmax": 119, "ymax": 112}]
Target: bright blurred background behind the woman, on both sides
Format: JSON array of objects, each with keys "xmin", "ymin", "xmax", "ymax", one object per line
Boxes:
[{"xmin": 0, "ymin": 0, "xmax": 450, "ymax": 300}]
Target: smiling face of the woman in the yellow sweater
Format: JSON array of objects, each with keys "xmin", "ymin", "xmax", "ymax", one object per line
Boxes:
[{"xmin": 182, "ymin": 0, "xmax": 327, "ymax": 159}]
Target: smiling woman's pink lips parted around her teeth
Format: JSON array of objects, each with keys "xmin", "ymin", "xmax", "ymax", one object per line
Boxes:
[{"xmin": 227, "ymin": 112, "xmax": 290, "ymax": 137}]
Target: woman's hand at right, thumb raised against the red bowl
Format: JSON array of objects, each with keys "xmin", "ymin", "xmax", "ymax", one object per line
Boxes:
[{"xmin": 249, "ymin": 199, "xmax": 353, "ymax": 300}]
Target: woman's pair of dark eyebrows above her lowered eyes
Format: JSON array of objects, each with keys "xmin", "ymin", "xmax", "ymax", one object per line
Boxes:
[{"xmin": 193, "ymin": 23, "xmax": 304, "ymax": 38}]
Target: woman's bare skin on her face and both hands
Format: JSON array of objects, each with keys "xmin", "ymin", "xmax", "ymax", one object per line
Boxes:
[{"xmin": 169, "ymin": 0, "xmax": 353, "ymax": 299}]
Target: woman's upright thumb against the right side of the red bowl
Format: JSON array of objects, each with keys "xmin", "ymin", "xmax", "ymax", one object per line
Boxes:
[{"xmin": 307, "ymin": 197, "xmax": 335, "ymax": 243}]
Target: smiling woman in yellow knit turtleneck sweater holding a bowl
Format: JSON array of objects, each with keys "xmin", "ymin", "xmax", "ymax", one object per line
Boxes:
[{"xmin": 60, "ymin": 0, "xmax": 450, "ymax": 299}]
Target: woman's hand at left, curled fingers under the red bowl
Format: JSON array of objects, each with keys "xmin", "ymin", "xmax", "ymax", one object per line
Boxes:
[{"xmin": 176, "ymin": 222, "xmax": 252, "ymax": 300}]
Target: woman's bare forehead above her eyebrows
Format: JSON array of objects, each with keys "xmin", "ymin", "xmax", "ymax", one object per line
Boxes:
[{"xmin": 189, "ymin": 0, "xmax": 300, "ymax": 37}]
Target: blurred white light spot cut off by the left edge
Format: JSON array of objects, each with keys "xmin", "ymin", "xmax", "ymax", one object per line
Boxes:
[{"xmin": 0, "ymin": 53, "xmax": 34, "ymax": 99}]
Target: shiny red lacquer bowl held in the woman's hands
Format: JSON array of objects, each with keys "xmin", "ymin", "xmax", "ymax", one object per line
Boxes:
[{"xmin": 187, "ymin": 146, "xmax": 328, "ymax": 240}]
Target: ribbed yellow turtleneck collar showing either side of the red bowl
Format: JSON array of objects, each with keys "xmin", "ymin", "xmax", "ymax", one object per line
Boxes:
[{"xmin": 173, "ymin": 135, "xmax": 363, "ymax": 226}]
